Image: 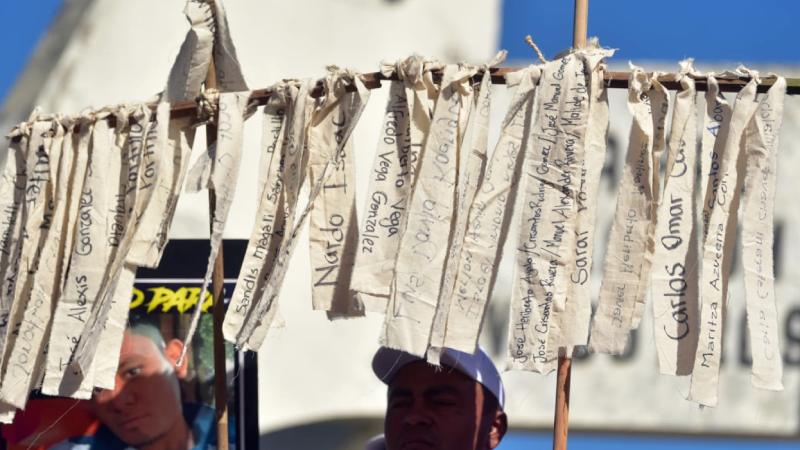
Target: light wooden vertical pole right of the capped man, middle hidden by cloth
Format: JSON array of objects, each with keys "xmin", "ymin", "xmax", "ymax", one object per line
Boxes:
[{"xmin": 553, "ymin": 0, "xmax": 589, "ymax": 450}]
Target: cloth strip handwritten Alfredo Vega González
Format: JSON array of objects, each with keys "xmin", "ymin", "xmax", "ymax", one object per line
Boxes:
[{"xmin": 350, "ymin": 56, "xmax": 436, "ymax": 313}]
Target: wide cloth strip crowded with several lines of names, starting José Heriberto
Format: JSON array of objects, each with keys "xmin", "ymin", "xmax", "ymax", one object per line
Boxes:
[{"xmin": 508, "ymin": 53, "xmax": 589, "ymax": 373}]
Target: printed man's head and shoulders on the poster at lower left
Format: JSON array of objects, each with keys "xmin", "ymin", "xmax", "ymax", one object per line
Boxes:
[{"xmin": 53, "ymin": 323, "xmax": 231, "ymax": 450}]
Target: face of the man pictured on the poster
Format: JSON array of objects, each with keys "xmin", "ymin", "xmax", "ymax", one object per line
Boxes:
[{"xmin": 92, "ymin": 331, "xmax": 183, "ymax": 446}]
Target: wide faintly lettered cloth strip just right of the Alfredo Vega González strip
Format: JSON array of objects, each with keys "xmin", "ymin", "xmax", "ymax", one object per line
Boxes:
[{"xmin": 383, "ymin": 64, "xmax": 476, "ymax": 356}]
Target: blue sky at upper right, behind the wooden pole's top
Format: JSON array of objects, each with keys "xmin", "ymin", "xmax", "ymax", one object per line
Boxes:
[{"xmin": 501, "ymin": 0, "xmax": 800, "ymax": 65}]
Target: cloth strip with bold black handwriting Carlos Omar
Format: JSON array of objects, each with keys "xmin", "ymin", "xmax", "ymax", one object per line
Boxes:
[{"xmin": 650, "ymin": 60, "xmax": 699, "ymax": 375}]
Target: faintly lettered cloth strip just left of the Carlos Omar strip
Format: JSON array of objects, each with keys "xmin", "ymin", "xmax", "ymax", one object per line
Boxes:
[{"xmin": 589, "ymin": 66, "xmax": 669, "ymax": 354}]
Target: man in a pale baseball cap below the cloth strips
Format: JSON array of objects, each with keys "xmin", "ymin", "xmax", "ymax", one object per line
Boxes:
[{"xmin": 367, "ymin": 347, "xmax": 508, "ymax": 450}]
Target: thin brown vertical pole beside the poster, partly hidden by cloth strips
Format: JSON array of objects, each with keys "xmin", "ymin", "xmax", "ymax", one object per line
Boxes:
[{"xmin": 205, "ymin": 53, "xmax": 228, "ymax": 450}]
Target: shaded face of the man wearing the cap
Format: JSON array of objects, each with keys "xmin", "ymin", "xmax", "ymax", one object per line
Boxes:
[{"xmin": 384, "ymin": 361, "xmax": 502, "ymax": 450}]
